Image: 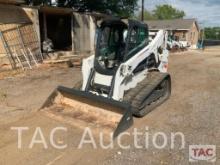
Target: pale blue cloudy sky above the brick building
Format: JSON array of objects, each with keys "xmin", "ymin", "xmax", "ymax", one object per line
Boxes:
[{"xmin": 139, "ymin": 0, "xmax": 220, "ymax": 27}]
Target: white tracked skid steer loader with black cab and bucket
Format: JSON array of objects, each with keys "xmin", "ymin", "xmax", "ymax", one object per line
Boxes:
[{"xmin": 41, "ymin": 19, "xmax": 171, "ymax": 137}]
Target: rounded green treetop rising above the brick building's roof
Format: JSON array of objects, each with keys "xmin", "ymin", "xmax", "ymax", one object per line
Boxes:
[{"xmin": 153, "ymin": 5, "xmax": 185, "ymax": 20}]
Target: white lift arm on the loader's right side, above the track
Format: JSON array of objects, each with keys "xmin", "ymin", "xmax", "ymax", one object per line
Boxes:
[{"xmin": 113, "ymin": 30, "xmax": 169, "ymax": 100}]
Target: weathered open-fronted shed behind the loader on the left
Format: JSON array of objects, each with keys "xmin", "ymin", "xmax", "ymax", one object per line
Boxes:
[{"xmin": 0, "ymin": 4, "xmax": 111, "ymax": 67}]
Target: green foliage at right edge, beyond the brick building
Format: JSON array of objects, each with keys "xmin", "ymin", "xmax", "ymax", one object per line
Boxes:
[{"xmin": 205, "ymin": 27, "xmax": 220, "ymax": 40}]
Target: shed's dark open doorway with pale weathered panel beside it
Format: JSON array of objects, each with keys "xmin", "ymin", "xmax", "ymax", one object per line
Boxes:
[{"xmin": 39, "ymin": 6, "xmax": 96, "ymax": 54}]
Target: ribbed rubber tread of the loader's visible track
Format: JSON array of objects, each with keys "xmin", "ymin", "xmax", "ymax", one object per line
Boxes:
[{"xmin": 124, "ymin": 72, "xmax": 169, "ymax": 117}]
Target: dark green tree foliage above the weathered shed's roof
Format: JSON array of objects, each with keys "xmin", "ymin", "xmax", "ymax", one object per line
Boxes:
[{"xmin": 26, "ymin": 0, "xmax": 138, "ymax": 17}]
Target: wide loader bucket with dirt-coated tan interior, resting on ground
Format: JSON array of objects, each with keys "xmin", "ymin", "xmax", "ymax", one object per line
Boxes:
[{"xmin": 41, "ymin": 86, "xmax": 133, "ymax": 138}]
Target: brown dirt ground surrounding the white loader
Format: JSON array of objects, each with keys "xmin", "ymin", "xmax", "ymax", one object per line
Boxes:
[{"xmin": 0, "ymin": 49, "xmax": 220, "ymax": 165}]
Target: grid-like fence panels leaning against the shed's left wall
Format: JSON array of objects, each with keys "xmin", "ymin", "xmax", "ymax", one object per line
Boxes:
[{"xmin": 0, "ymin": 24, "xmax": 43, "ymax": 69}]
